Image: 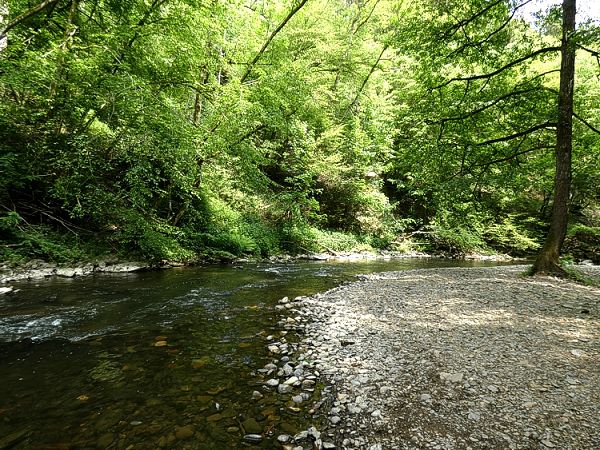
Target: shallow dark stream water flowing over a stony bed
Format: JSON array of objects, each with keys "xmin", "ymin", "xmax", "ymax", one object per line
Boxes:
[{"xmin": 0, "ymin": 258, "xmax": 516, "ymax": 450}]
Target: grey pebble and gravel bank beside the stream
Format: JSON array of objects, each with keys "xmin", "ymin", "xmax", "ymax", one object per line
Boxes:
[{"xmin": 288, "ymin": 266, "xmax": 600, "ymax": 450}]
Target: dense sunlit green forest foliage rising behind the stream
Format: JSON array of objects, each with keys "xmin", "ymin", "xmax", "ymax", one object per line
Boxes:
[{"xmin": 0, "ymin": 0, "xmax": 600, "ymax": 263}]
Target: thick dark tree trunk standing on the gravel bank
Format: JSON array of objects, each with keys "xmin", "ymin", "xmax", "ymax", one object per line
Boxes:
[{"xmin": 532, "ymin": 0, "xmax": 576, "ymax": 275}]
